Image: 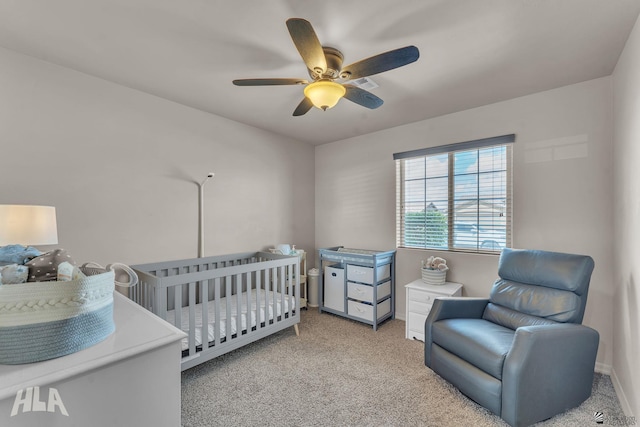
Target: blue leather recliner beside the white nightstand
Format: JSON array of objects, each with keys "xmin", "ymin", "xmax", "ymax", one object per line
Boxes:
[{"xmin": 424, "ymin": 249, "xmax": 599, "ymax": 426}]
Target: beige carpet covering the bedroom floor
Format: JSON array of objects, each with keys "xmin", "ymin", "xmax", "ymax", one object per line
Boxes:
[{"xmin": 182, "ymin": 309, "xmax": 624, "ymax": 427}]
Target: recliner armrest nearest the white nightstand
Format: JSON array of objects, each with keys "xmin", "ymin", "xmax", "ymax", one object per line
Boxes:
[{"xmin": 424, "ymin": 297, "xmax": 489, "ymax": 367}]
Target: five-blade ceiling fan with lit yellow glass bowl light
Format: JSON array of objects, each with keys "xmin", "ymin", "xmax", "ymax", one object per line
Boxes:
[{"xmin": 233, "ymin": 18, "xmax": 420, "ymax": 116}]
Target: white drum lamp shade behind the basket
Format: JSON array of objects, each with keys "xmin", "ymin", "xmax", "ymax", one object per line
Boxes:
[{"xmin": 0, "ymin": 205, "xmax": 58, "ymax": 246}]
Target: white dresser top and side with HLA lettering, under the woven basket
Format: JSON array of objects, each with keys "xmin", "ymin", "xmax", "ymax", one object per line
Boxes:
[{"xmin": 0, "ymin": 292, "xmax": 185, "ymax": 427}]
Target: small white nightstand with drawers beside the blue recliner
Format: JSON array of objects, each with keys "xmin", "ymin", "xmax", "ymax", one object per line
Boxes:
[{"xmin": 405, "ymin": 279, "xmax": 462, "ymax": 341}]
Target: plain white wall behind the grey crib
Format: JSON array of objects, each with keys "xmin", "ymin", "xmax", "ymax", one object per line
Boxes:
[{"xmin": 0, "ymin": 49, "xmax": 314, "ymax": 264}]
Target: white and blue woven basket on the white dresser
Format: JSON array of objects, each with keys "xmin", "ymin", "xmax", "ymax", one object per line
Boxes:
[{"xmin": 0, "ymin": 271, "xmax": 115, "ymax": 365}]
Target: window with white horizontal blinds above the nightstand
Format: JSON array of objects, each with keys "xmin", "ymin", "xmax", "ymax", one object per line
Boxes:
[{"xmin": 393, "ymin": 135, "xmax": 515, "ymax": 253}]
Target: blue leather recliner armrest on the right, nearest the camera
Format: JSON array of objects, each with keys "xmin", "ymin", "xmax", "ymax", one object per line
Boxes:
[{"xmin": 501, "ymin": 323, "xmax": 599, "ymax": 426}]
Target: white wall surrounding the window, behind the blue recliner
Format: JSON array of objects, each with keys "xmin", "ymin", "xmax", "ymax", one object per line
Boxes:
[{"xmin": 316, "ymin": 78, "xmax": 613, "ymax": 372}]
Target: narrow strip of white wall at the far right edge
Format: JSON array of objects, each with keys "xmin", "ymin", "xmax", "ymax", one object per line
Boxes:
[{"xmin": 612, "ymin": 12, "xmax": 640, "ymax": 416}]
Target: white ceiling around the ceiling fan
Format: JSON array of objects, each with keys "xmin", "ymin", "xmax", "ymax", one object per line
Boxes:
[{"xmin": 0, "ymin": 0, "xmax": 640, "ymax": 144}]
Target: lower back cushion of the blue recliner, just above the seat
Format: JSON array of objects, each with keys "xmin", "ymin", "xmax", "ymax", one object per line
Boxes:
[{"xmin": 489, "ymin": 279, "xmax": 582, "ymax": 326}]
